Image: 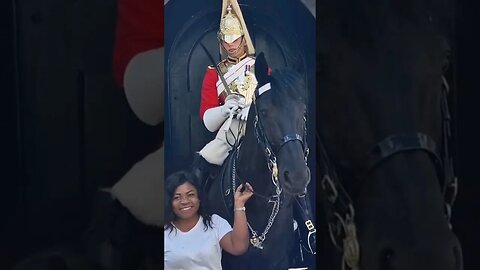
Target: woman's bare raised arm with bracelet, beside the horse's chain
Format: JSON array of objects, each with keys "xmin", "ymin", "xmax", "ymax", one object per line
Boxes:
[{"xmin": 220, "ymin": 183, "xmax": 253, "ymax": 256}]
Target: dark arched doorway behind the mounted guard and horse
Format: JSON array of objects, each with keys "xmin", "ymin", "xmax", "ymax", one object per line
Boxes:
[{"xmin": 165, "ymin": 0, "xmax": 315, "ymax": 175}]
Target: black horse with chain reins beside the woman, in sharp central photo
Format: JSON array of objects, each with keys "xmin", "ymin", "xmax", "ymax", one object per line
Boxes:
[{"xmin": 202, "ymin": 54, "xmax": 310, "ymax": 269}]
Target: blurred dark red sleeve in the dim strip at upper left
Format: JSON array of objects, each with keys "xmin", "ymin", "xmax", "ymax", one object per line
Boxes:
[{"xmin": 113, "ymin": 0, "xmax": 164, "ymax": 87}]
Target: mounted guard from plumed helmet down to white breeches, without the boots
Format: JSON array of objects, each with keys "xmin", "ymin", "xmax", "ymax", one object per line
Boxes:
[{"xmin": 193, "ymin": 1, "xmax": 257, "ymax": 169}]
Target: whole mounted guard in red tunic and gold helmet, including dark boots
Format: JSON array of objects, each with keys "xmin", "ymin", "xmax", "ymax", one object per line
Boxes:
[{"xmin": 192, "ymin": 0, "xmax": 316, "ymax": 260}]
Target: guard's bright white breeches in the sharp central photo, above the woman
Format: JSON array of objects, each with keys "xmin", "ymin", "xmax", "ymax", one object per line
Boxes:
[{"xmin": 199, "ymin": 119, "xmax": 246, "ymax": 166}]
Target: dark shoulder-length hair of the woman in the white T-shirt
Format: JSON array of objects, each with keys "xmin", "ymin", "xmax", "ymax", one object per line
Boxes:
[{"xmin": 164, "ymin": 171, "xmax": 212, "ymax": 232}]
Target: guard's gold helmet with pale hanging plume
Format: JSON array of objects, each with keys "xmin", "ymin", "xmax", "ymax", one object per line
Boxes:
[{"xmin": 218, "ymin": 0, "xmax": 255, "ymax": 54}]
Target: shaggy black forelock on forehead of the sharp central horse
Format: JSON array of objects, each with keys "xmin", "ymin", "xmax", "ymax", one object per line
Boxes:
[{"xmin": 271, "ymin": 67, "xmax": 307, "ymax": 103}]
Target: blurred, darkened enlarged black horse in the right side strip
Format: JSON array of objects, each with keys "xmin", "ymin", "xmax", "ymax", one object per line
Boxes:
[{"xmin": 317, "ymin": 0, "xmax": 463, "ymax": 270}]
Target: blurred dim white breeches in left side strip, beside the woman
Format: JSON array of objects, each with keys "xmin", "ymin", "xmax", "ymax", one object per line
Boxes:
[{"xmin": 110, "ymin": 147, "xmax": 164, "ymax": 227}]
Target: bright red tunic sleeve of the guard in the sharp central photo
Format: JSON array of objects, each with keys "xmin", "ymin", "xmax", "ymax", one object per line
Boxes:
[{"xmin": 200, "ymin": 68, "xmax": 227, "ymax": 120}]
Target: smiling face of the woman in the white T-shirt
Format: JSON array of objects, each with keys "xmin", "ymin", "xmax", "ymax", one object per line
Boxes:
[{"xmin": 172, "ymin": 183, "xmax": 200, "ymax": 219}]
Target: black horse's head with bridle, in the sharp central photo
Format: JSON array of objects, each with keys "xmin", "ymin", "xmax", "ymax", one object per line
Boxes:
[{"xmin": 247, "ymin": 53, "xmax": 310, "ymax": 194}]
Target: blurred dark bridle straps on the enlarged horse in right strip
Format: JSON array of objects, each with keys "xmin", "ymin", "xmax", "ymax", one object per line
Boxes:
[{"xmin": 317, "ymin": 76, "xmax": 458, "ymax": 270}]
